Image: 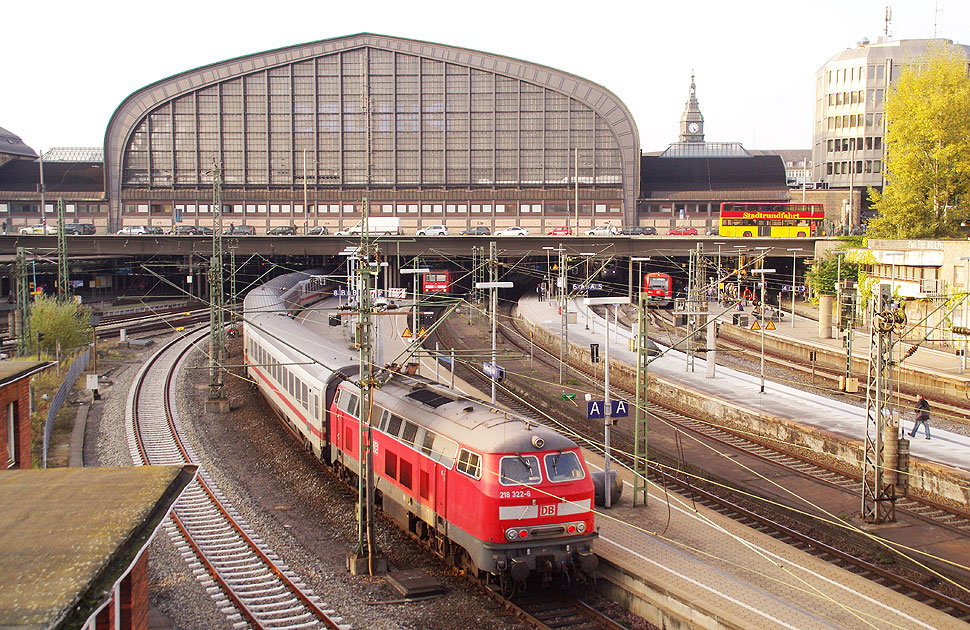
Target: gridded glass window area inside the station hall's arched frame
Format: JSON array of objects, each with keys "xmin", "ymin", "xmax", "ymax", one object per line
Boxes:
[{"xmin": 124, "ymin": 48, "xmax": 621, "ymax": 187}]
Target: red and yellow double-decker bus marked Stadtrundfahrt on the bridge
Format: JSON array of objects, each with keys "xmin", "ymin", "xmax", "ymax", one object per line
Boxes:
[{"xmin": 718, "ymin": 201, "xmax": 825, "ymax": 238}]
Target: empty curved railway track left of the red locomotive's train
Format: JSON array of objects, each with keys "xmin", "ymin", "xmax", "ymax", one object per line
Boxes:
[{"xmin": 125, "ymin": 329, "xmax": 350, "ymax": 630}]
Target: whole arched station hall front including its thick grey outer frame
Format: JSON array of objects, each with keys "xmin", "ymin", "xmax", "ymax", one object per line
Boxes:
[{"xmin": 105, "ymin": 34, "xmax": 639, "ymax": 232}]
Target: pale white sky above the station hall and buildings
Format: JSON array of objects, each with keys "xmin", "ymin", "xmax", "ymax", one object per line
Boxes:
[{"xmin": 7, "ymin": 0, "xmax": 970, "ymax": 151}]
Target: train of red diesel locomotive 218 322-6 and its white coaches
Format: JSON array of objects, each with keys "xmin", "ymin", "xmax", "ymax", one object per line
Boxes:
[{"xmin": 244, "ymin": 274, "xmax": 597, "ymax": 590}]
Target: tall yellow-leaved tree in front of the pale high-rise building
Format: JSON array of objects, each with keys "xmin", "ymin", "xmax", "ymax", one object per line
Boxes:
[{"xmin": 866, "ymin": 47, "xmax": 970, "ymax": 238}]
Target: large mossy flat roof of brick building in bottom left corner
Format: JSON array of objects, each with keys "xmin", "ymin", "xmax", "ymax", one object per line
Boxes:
[{"xmin": 0, "ymin": 466, "xmax": 198, "ymax": 630}]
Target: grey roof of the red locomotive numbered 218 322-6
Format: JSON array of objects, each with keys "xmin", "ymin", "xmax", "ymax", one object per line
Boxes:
[{"xmin": 374, "ymin": 375, "xmax": 576, "ymax": 453}]
